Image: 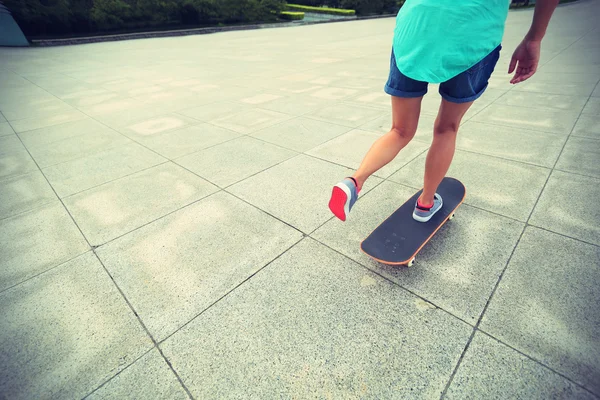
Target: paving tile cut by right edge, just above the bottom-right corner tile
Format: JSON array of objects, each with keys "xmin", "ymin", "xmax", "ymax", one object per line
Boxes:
[{"xmin": 480, "ymin": 228, "xmax": 600, "ymax": 395}]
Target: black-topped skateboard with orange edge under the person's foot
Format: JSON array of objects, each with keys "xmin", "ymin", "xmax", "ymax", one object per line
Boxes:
[{"xmin": 360, "ymin": 177, "xmax": 466, "ymax": 267}]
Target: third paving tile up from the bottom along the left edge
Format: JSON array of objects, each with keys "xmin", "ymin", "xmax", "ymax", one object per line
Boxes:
[{"xmin": 0, "ymin": 171, "xmax": 57, "ymax": 218}]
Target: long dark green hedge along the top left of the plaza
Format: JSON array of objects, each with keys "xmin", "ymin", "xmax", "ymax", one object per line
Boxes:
[{"xmin": 0, "ymin": 0, "xmax": 285, "ymax": 39}]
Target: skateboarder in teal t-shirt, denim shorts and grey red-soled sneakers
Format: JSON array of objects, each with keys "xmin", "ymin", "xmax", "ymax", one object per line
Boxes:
[{"xmin": 329, "ymin": 0, "xmax": 558, "ymax": 222}]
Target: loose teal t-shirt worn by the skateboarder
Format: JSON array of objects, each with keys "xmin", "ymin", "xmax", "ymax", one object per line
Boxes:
[{"xmin": 393, "ymin": 0, "xmax": 509, "ymax": 83}]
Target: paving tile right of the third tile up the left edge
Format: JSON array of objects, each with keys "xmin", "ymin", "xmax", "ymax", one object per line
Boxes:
[{"xmin": 43, "ymin": 143, "xmax": 167, "ymax": 198}]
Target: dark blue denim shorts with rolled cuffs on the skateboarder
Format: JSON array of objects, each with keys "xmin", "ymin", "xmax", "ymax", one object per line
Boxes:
[{"xmin": 385, "ymin": 46, "xmax": 502, "ymax": 103}]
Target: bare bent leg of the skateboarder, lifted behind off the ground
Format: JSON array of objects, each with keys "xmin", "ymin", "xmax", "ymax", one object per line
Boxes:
[{"xmin": 352, "ymin": 96, "xmax": 423, "ymax": 190}]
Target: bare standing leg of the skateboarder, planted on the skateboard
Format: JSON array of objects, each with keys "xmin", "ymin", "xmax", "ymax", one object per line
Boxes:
[{"xmin": 420, "ymin": 99, "xmax": 473, "ymax": 205}]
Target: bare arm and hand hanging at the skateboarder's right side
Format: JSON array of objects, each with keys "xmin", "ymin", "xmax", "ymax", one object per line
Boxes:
[{"xmin": 508, "ymin": 0, "xmax": 558, "ymax": 83}]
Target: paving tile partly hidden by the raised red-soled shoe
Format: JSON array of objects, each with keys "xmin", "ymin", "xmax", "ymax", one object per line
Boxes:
[{"xmin": 229, "ymin": 155, "xmax": 381, "ymax": 233}]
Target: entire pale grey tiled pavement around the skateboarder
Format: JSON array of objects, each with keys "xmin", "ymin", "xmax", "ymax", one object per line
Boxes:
[{"xmin": 0, "ymin": 0, "xmax": 600, "ymax": 399}]
